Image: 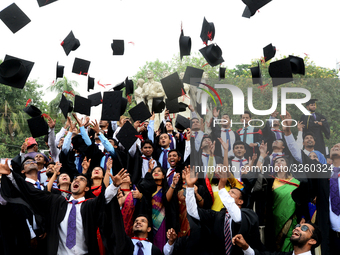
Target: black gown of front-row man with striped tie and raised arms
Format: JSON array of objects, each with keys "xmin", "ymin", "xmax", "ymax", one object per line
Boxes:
[{"xmin": 198, "ymin": 208, "xmax": 263, "ymax": 255}]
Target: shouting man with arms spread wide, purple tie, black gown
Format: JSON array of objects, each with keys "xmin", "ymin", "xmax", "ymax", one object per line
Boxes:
[{"xmin": 0, "ymin": 160, "xmax": 128, "ymax": 255}]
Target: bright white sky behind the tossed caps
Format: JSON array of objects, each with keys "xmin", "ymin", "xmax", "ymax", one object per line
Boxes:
[{"xmin": 0, "ymin": 0, "xmax": 340, "ymax": 115}]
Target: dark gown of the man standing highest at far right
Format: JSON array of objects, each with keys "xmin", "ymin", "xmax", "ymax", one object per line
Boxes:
[{"xmin": 300, "ymin": 112, "xmax": 330, "ymax": 156}]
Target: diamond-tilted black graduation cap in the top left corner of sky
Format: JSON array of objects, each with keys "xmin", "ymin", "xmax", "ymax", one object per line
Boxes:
[{"xmin": 0, "ymin": 3, "xmax": 31, "ymax": 34}]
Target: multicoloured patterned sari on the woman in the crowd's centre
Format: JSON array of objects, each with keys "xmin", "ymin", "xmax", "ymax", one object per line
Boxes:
[{"xmin": 151, "ymin": 189, "xmax": 166, "ymax": 251}]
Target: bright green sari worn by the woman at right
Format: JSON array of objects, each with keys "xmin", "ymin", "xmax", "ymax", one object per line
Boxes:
[{"xmin": 273, "ymin": 178, "xmax": 300, "ymax": 252}]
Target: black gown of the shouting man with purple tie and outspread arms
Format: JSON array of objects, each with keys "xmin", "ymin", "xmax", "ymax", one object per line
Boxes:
[{"xmin": 1, "ymin": 173, "xmax": 105, "ymax": 255}]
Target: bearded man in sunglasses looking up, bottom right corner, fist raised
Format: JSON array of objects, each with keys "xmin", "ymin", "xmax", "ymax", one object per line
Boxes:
[{"xmin": 232, "ymin": 223, "xmax": 322, "ymax": 255}]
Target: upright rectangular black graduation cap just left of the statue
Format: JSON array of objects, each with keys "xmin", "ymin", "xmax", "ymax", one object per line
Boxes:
[{"xmin": 100, "ymin": 91, "xmax": 123, "ymax": 121}]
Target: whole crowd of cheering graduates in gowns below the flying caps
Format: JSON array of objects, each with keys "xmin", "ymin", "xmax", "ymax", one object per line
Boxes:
[{"xmin": 0, "ymin": 96, "xmax": 340, "ymax": 255}]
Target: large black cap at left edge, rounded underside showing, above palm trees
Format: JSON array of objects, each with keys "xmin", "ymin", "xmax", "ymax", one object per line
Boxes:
[{"xmin": 0, "ymin": 55, "xmax": 34, "ymax": 89}]
